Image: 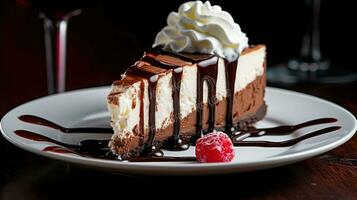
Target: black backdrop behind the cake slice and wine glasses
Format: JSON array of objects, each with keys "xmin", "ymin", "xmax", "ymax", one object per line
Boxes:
[{"xmin": 0, "ymin": 0, "xmax": 357, "ymax": 114}]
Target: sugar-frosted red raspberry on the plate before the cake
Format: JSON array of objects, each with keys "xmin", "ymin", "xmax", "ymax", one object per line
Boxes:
[{"xmin": 196, "ymin": 131, "xmax": 234, "ymax": 162}]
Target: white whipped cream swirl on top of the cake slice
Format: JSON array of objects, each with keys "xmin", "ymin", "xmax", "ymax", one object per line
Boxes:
[{"xmin": 153, "ymin": 1, "xmax": 248, "ymax": 61}]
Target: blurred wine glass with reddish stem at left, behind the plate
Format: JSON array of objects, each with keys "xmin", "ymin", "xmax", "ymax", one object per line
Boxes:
[{"xmin": 16, "ymin": 0, "xmax": 91, "ymax": 94}]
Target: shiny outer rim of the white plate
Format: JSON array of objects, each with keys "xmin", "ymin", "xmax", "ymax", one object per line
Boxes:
[{"xmin": 0, "ymin": 86, "xmax": 357, "ymax": 175}]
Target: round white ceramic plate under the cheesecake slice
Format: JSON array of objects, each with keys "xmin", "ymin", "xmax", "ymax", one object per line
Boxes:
[{"xmin": 0, "ymin": 87, "xmax": 357, "ymax": 175}]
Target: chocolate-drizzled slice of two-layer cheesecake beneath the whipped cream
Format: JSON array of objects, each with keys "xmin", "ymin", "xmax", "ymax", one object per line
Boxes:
[{"xmin": 107, "ymin": 45, "xmax": 266, "ymax": 158}]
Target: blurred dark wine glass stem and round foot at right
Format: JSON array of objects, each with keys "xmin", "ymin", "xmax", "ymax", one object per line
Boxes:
[{"xmin": 267, "ymin": 0, "xmax": 357, "ymax": 86}]
